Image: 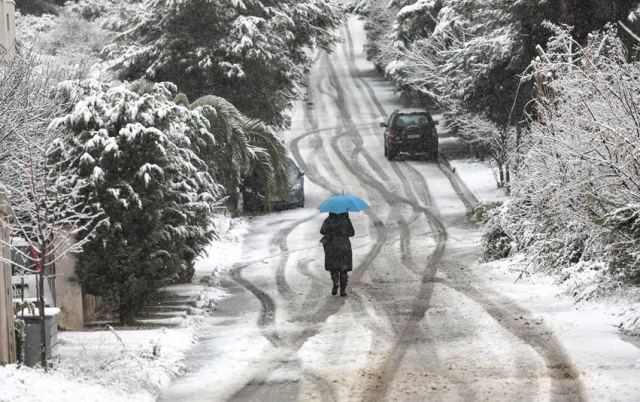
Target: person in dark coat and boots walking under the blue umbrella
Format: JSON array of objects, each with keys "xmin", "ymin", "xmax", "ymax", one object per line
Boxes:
[{"xmin": 320, "ymin": 212, "xmax": 355, "ymax": 297}]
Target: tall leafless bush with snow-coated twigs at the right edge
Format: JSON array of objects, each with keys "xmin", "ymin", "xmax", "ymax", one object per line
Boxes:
[{"xmin": 488, "ymin": 24, "xmax": 640, "ymax": 298}]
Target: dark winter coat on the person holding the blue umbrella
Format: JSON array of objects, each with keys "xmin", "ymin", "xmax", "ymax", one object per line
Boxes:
[{"xmin": 320, "ymin": 213, "xmax": 355, "ymax": 271}]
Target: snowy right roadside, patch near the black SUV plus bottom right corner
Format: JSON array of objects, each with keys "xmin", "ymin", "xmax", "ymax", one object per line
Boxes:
[{"xmin": 451, "ymin": 156, "xmax": 640, "ymax": 401}]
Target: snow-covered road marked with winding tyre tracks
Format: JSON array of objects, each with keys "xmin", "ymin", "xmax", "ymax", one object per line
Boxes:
[{"xmin": 161, "ymin": 17, "xmax": 585, "ymax": 401}]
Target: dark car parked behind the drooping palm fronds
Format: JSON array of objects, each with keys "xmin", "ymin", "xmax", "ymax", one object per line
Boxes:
[{"xmin": 242, "ymin": 158, "xmax": 304, "ymax": 212}]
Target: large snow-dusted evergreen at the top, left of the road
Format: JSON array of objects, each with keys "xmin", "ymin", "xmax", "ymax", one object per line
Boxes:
[{"xmin": 105, "ymin": 0, "xmax": 342, "ymax": 126}]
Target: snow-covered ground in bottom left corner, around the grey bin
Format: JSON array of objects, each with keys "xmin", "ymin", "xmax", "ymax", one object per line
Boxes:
[{"xmin": 0, "ymin": 327, "xmax": 195, "ymax": 402}]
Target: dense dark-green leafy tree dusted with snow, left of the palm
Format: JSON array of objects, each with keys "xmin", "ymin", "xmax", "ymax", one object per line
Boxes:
[{"xmin": 55, "ymin": 81, "xmax": 223, "ymax": 322}]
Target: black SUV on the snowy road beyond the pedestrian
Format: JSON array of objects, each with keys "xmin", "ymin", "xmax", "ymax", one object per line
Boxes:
[{"xmin": 380, "ymin": 109, "xmax": 438, "ymax": 161}]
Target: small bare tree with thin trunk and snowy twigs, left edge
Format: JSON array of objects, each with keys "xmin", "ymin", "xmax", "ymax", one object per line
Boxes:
[{"xmin": 0, "ymin": 51, "xmax": 102, "ymax": 369}]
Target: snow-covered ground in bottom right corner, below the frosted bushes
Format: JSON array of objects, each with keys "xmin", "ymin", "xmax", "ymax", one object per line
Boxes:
[{"xmin": 476, "ymin": 260, "xmax": 640, "ymax": 401}]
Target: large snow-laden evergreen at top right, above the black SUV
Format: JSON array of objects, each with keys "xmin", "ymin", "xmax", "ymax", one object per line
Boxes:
[{"xmin": 367, "ymin": 0, "xmax": 638, "ymax": 126}]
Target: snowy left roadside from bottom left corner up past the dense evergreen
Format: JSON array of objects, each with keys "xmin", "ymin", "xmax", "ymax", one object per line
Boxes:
[{"xmin": 0, "ymin": 217, "xmax": 246, "ymax": 402}]
